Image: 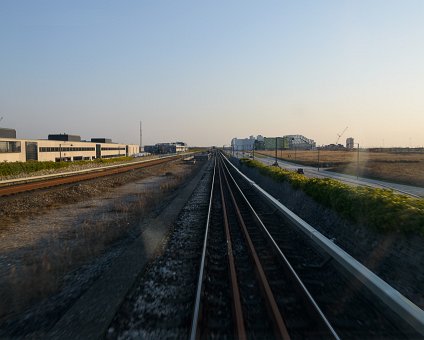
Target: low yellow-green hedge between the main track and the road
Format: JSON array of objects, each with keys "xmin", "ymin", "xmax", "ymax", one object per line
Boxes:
[{"xmin": 241, "ymin": 159, "xmax": 424, "ymax": 236}]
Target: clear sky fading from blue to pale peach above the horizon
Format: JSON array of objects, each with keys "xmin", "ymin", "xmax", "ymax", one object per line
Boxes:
[{"xmin": 0, "ymin": 0, "xmax": 424, "ymax": 146}]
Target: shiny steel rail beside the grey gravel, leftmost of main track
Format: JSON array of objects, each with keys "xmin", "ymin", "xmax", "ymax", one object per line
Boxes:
[{"xmin": 190, "ymin": 157, "xmax": 217, "ymax": 340}]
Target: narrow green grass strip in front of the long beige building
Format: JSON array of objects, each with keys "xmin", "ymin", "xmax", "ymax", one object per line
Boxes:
[{"xmin": 0, "ymin": 157, "xmax": 133, "ymax": 177}]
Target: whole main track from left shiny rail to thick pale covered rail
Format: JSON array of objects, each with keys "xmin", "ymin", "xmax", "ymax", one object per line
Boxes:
[{"xmin": 190, "ymin": 156, "xmax": 421, "ymax": 340}]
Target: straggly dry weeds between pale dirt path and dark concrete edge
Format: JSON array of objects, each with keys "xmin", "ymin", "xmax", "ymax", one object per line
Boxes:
[{"xmin": 0, "ymin": 162, "xmax": 197, "ymax": 318}]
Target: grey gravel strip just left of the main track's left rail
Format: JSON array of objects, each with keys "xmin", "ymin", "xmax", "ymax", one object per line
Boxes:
[{"xmin": 107, "ymin": 162, "xmax": 212, "ymax": 339}]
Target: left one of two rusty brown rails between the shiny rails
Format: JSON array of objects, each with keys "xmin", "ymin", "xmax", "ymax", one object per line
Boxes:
[{"xmin": 219, "ymin": 158, "xmax": 247, "ymax": 340}]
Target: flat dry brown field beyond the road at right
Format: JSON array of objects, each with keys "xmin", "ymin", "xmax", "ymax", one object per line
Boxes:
[{"xmin": 257, "ymin": 150, "xmax": 424, "ymax": 187}]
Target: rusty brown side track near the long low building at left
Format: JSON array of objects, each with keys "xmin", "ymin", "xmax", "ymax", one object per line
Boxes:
[{"xmin": 0, "ymin": 156, "xmax": 179, "ymax": 197}]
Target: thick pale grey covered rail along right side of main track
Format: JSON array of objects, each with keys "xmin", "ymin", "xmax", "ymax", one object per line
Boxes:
[{"xmin": 224, "ymin": 153, "xmax": 424, "ymax": 336}]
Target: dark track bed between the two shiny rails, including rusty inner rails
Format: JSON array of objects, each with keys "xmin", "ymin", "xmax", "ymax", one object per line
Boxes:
[{"xmin": 191, "ymin": 155, "xmax": 338, "ymax": 339}]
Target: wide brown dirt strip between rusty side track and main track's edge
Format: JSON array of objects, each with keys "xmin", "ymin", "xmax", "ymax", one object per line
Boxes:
[{"xmin": 0, "ymin": 162, "xmax": 202, "ymax": 335}]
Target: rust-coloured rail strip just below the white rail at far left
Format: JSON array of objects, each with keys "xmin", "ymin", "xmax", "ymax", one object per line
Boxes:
[{"xmin": 0, "ymin": 156, "xmax": 179, "ymax": 197}]
